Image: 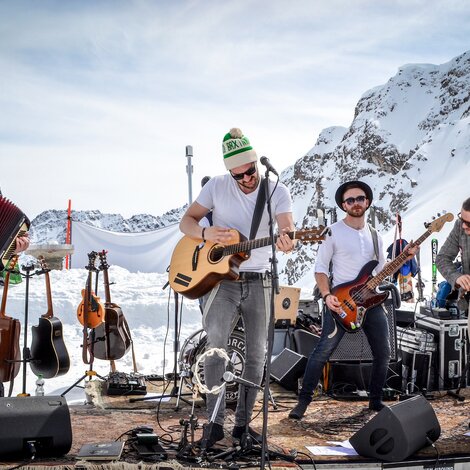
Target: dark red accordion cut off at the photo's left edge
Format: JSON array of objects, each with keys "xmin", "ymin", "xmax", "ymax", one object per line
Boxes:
[{"xmin": 0, "ymin": 196, "xmax": 30, "ymax": 268}]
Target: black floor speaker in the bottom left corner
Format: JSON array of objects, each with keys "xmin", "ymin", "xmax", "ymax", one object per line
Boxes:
[{"xmin": 0, "ymin": 396, "xmax": 72, "ymax": 459}]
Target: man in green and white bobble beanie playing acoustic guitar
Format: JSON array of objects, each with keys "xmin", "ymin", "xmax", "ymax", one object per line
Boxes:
[{"xmin": 180, "ymin": 128, "xmax": 294, "ymax": 449}]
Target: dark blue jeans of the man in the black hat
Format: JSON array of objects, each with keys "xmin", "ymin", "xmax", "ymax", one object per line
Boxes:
[{"xmin": 299, "ymin": 305, "xmax": 390, "ymax": 402}]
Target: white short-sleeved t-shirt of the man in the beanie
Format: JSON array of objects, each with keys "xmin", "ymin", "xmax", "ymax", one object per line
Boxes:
[{"xmin": 196, "ymin": 174, "xmax": 292, "ymax": 272}]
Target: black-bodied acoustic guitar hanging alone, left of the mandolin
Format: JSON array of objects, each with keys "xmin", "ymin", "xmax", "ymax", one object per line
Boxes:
[{"xmin": 30, "ymin": 257, "xmax": 70, "ymax": 379}]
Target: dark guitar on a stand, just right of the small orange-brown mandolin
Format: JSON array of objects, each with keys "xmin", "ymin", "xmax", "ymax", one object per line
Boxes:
[{"xmin": 93, "ymin": 250, "xmax": 132, "ymax": 360}]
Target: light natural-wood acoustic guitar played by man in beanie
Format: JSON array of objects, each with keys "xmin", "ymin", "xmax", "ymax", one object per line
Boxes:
[{"xmin": 169, "ymin": 226, "xmax": 326, "ymax": 299}]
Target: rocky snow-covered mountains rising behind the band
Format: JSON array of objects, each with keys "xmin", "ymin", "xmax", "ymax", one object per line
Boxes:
[{"xmin": 31, "ymin": 51, "xmax": 470, "ymax": 283}]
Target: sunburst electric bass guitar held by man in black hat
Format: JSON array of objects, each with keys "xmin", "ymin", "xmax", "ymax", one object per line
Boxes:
[{"xmin": 331, "ymin": 213, "xmax": 454, "ymax": 333}]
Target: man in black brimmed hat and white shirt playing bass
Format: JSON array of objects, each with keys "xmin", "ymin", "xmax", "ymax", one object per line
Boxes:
[{"xmin": 289, "ymin": 181, "xmax": 417, "ymax": 419}]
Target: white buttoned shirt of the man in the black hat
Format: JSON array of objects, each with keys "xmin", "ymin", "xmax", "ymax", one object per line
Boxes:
[{"xmin": 315, "ymin": 220, "xmax": 385, "ymax": 287}]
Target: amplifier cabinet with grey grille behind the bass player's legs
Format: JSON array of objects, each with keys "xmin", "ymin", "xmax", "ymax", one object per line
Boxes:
[{"xmin": 329, "ymin": 300, "xmax": 397, "ymax": 362}]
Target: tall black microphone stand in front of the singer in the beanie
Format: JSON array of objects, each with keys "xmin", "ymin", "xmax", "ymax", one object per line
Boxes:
[{"xmin": 260, "ymin": 168, "xmax": 279, "ymax": 469}]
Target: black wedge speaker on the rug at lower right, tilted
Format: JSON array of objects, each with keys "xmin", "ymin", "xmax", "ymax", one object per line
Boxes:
[{"xmin": 349, "ymin": 395, "xmax": 441, "ymax": 462}]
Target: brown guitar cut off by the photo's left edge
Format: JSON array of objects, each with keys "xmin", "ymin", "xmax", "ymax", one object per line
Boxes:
[{"xmin": 0, "ymin": 255, "xmax": 21, "ymax": 386}]
